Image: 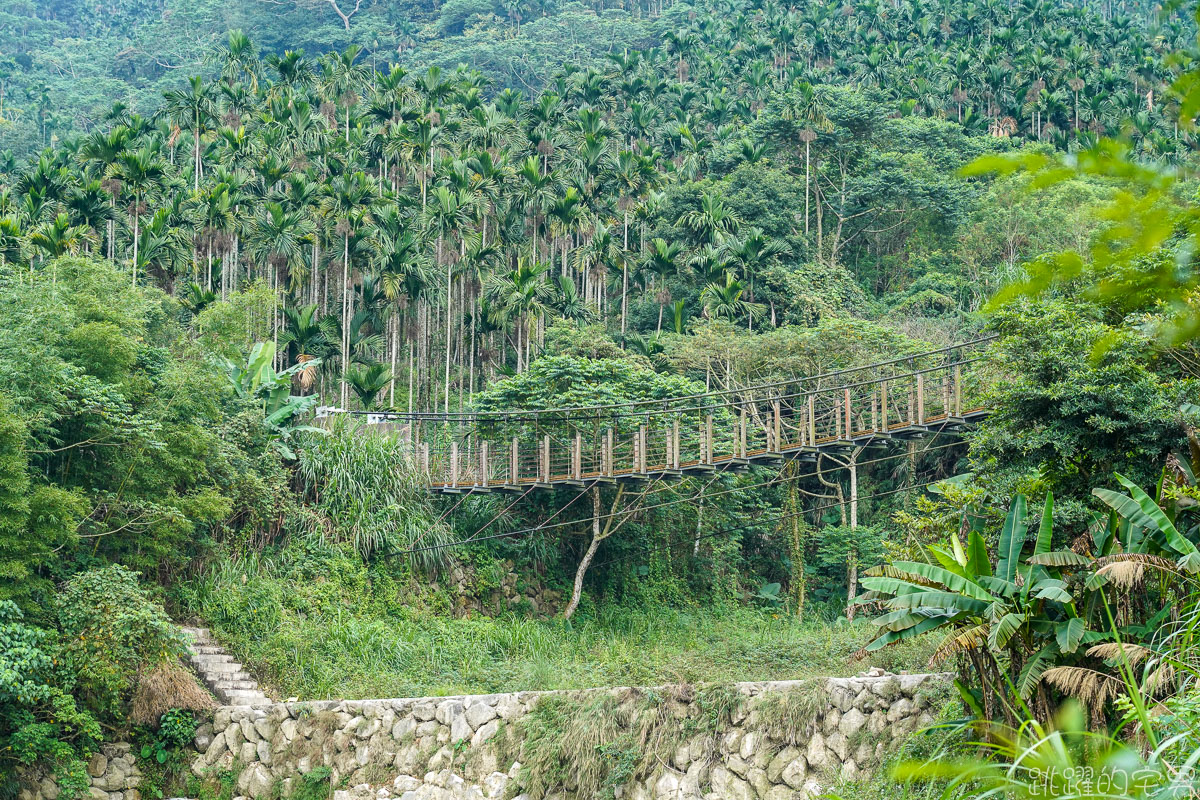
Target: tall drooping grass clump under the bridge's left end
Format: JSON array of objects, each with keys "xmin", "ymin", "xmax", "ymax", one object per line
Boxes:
[{"xmin": 296, "ymin": 419, "xmax": 452, "ymax": 571}]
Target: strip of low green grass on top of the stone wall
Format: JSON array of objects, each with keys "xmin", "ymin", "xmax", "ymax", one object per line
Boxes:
[{"xmin": 188, "ymin": 544, "xmax": 929, "ymax": 699}]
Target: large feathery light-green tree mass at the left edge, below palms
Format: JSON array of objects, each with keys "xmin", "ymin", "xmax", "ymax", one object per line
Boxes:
[{"xmin": 0, "ymin": 258, "xmax": 295, "ymax": 578}]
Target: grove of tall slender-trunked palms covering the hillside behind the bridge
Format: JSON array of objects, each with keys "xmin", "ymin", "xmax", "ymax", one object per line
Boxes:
[{"xmin": 0, "ymin": 0, "xmax": 1193, "ymax": 410}]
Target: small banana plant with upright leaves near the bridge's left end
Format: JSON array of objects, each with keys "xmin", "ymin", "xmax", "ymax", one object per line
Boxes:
[{"xmin": 224, "ymin": 342, "xmax": 323, "ymax": 461}]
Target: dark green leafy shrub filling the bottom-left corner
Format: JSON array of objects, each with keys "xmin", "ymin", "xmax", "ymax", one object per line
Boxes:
[{"xmin": 0, "ymin": 600, "xmax": 102, "ymax": 798}]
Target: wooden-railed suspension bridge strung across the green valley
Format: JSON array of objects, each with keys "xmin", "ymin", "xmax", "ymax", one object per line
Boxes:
[{"xmin": 324, "ymin": 336, "xmax": 996, "ymax": 494}]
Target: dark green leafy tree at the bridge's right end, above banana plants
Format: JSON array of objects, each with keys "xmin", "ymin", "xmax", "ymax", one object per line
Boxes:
[{"xmin": 971, "ymin": 299, "xmax": 1196, "ymax": 515}]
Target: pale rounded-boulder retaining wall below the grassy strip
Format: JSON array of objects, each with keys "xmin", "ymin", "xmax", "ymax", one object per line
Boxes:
[{"xmin": 194, "ymin": 675, "xmax": 948, "ymax": 800}]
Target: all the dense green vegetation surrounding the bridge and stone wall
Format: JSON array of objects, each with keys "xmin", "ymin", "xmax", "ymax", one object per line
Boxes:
[{"xmin": 0, "ymin": 0, "xmax": 1200, "ymax": 798}]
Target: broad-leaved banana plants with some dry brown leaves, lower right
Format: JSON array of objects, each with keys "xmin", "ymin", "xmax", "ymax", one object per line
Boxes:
[{"xmin": 859, "ymin": 489, "xmax": 1200, "ymax": 724}]
